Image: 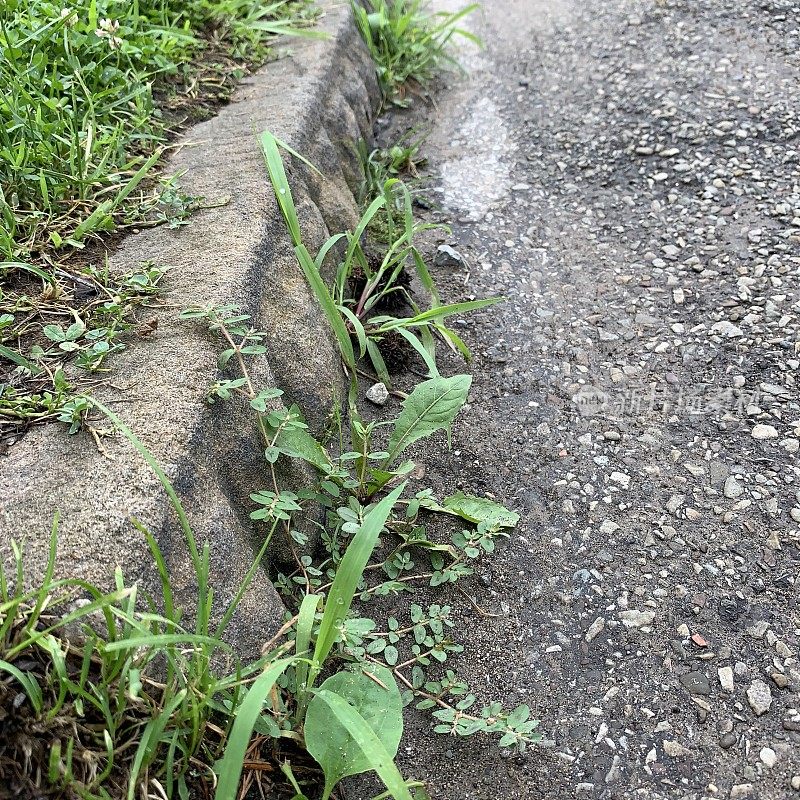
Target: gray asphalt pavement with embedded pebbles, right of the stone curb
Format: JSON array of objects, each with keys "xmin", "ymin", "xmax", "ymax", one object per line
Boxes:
[{"xmin": 360, "ymin": 0, "xmax": 800, "ymax": 800}]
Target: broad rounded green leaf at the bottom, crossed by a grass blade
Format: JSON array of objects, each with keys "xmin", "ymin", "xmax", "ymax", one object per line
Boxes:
[{"xmin": 305, "ymin": 664, "xmax": 403, "ymax": 791}]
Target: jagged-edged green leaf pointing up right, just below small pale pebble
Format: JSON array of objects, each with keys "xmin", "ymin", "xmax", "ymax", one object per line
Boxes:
[{"xmin": 383, "ymin": 375, "xmax": 472, "ymax": 467}]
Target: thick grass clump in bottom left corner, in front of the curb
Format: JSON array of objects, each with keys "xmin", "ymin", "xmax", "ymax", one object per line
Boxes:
[{"xmin": 0, "ymin": 525, "xmax": 288, "ymax": 800}]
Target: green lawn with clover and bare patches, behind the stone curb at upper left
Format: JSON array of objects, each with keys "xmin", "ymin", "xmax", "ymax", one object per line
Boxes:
[{"xmin": 0, "ymin": 0, "xmax": 316, "ymax": 441}]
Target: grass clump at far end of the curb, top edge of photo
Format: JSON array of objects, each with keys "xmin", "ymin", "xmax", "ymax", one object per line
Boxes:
[{"xmin": 352, "ymin": 0, "xmax": 479, "ymax": 105}]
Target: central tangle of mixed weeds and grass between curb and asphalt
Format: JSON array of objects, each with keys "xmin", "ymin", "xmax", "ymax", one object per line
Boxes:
[{"xmin": 172, "ymin": 134, "xmax": 541, "ymax": 800}]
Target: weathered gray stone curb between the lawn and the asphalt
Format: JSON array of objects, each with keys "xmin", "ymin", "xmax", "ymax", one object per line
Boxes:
[{"xmin": 0, "ymin": 3, "xmax": 379, "ymax": 653}]
